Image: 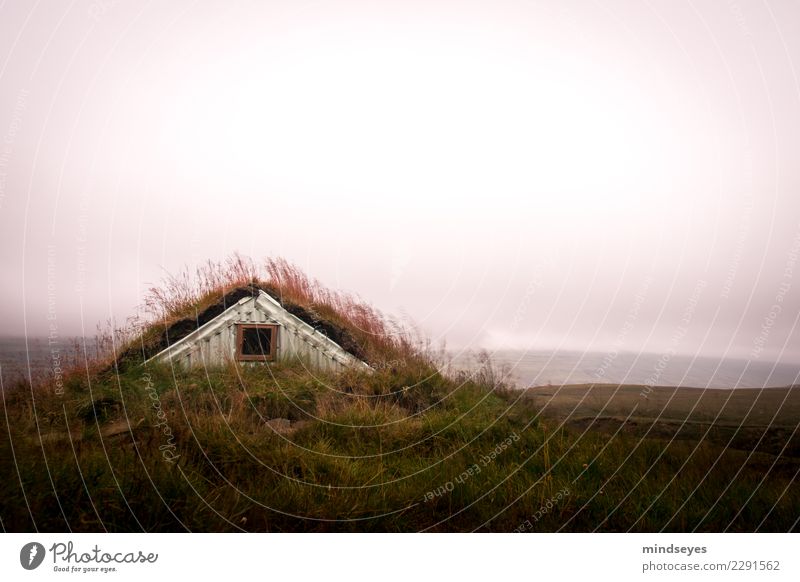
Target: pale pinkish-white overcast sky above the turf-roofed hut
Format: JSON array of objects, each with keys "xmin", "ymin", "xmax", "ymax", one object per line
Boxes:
[{"xmin": 0, "ymin": 0, "xmax": 800, "ymax": 361}]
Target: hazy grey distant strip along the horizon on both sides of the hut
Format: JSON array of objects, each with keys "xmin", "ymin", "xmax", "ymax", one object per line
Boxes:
[{"xmin": 0, "ymin": 337, "xmax": 800, "ymax": 389}]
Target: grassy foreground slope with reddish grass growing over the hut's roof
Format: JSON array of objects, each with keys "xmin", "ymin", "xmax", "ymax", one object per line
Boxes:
[{"xmin": 0, "ymin": 258, "xmax": 800, "ymax": 532}]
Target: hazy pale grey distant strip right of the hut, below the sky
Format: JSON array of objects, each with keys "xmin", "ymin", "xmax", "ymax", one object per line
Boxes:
[{"xmin": 453, "ymin": 350, "xmax": 800, "ymax": 388}]
